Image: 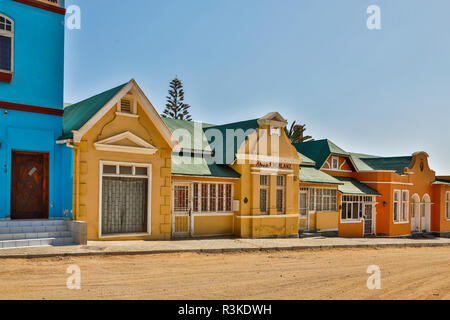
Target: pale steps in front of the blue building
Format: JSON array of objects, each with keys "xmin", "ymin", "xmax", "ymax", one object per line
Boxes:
[{"xmin": 0, "ymin": 220, "xmax": 75, "ymax": 250}]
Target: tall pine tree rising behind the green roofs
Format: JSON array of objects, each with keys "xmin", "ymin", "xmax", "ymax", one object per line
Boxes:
[{"xmin": 161, "ymin": 77, "xmax": 192, "ymax": 121}]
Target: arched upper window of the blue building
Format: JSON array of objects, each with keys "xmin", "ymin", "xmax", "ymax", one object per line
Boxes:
[{"xmin": 0, "ymin": 14, "xmax": 14, "ymax": 72}]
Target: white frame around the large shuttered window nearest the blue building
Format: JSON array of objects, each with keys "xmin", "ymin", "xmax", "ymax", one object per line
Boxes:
[{"xmin": 98, "ymin": 160, "xmax": 152, "ymax": 239}]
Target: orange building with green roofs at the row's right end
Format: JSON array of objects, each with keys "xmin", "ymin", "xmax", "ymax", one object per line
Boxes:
[{"xmin": 295, "ymin": 140, "xmax": 450, "ymax": 237}]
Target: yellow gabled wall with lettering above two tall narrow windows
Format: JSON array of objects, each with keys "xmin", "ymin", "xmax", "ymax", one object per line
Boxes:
[{"xmin": 232, "ymin": 125, "xmax": 300, "ymax": 237}]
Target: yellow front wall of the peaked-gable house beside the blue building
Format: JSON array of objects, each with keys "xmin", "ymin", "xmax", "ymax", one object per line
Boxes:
[{"xmin": 74, "ymin": 94, "xmax": 171, "ymax": 240}]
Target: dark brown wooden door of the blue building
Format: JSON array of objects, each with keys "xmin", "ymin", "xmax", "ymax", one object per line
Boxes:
[{"xmin": 11, "ymin": 151, "xmax": 48, "ymax": 219}]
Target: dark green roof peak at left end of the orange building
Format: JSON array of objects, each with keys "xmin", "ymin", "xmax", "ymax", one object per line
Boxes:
[{"xmin": 293, "ymin": 139, "xmax": 349, "ymax": 169}]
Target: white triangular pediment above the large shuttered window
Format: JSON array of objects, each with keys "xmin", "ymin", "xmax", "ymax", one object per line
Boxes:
[{"xmin": 94, "ymin": 131, "xmax": 158, "ymax": 155}]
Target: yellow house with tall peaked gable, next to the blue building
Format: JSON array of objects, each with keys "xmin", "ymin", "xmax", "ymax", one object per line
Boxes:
[{"xmin": 59, "ymin": 80, "xmax": 175, "ymax": 240}]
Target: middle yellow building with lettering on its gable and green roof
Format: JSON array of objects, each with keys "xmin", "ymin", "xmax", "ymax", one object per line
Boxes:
[{"xmin": 165, "ymin": 113, "xmax": 301, "ymax": 237}]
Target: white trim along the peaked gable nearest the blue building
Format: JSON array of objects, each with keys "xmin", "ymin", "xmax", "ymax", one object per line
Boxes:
[{"xmin": 72, "ymin": 79, "xmax": 176, "ymax": 149}]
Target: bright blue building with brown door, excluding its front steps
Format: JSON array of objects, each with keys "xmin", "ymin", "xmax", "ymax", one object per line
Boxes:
[{"xmin": 0, "ymin": 0, "xmax": 72, "ymax": 221}]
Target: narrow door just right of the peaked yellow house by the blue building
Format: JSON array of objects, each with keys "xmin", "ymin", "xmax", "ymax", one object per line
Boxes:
[{"xmin": 172, "ymin": 184, "xmax": 191, "ymax": 237}]
